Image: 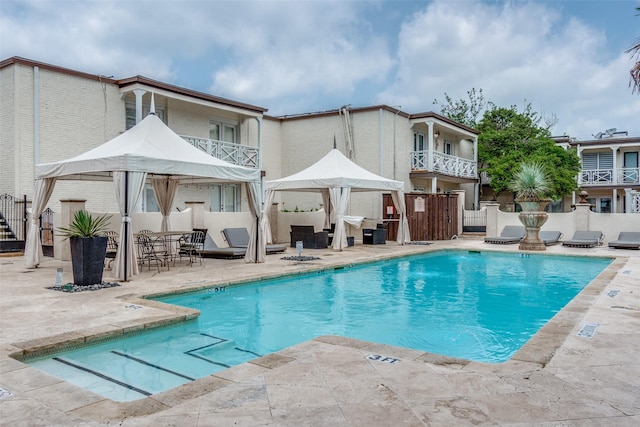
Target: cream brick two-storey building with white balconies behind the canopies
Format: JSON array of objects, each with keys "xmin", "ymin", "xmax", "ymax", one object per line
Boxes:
[{"xmin": 0, "ymin": 57, "xmax": 479, "ymax": 224}]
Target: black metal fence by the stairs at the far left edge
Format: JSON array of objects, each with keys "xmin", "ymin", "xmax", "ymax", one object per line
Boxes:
[{"xmin": 0, "ymin": 194, "xmax": 27, "ymax": 252}]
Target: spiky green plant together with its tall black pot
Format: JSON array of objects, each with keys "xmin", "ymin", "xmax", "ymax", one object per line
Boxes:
[{"xmin": 58, "ymin": 210, "xmax": 111, "ymax": 286}]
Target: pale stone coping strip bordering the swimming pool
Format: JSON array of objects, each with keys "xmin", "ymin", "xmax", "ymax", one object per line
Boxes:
[{"xmin": 2, "ymin": 248, "xmax": 628, "ymax": 421}]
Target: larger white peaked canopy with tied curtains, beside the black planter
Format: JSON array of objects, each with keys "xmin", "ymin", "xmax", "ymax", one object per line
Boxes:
[{"xmin": 25, "ymin": 114, "xmax": 265, "ymax": 280}]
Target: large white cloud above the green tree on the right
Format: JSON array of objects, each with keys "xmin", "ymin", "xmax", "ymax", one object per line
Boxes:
[{"xmin": 378, "ymin": 2, "xmax": 640, "ymax": 137}]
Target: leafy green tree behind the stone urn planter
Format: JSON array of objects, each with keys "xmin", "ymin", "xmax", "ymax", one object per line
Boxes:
[{"xmin": 477, "ymin": 104, "xmax": 580, "ymax": 200}]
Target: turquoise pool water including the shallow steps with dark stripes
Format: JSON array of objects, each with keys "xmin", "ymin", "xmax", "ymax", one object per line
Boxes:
[{"xmin": 27, "ymin": 251, "xmax": 611, "ymax": 401}]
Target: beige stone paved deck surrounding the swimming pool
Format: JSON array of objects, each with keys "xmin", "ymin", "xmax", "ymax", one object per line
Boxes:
[{"xmin": 0, "ymin": 239, "xmax": 640, "ymax": 426}]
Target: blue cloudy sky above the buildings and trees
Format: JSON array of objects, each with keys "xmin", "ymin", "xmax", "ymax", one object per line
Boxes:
[{"xmin": 0, "ymin": 0, "xmax": 640, "ymax": 140}]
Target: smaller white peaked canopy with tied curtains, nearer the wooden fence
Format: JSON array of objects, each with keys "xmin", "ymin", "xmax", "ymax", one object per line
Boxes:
[{"xmin": 262, "ymin": 148, "xmax": 411, "ymax": 250}]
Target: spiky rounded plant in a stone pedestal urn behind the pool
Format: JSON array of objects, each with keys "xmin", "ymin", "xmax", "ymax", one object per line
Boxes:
[{"xmin": 510, "ymin": 162, "xmax": 551, "ymax": 251}]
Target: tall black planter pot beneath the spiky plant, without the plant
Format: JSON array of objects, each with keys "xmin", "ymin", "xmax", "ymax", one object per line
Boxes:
[{"xmin": 69, "ymin": 237, "xmax": 107, "ymax": 286}]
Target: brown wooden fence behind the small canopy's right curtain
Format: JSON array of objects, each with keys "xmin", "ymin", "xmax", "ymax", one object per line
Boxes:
[{"xmin": 382, "ymin": 193, "xmax": 458, "ymax": 241}]
